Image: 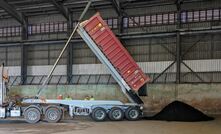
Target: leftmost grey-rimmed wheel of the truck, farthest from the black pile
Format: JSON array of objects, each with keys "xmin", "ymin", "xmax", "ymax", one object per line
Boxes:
[{"xmin": 24, "ymin": 107, "xmax": 41, "ymax": 124}]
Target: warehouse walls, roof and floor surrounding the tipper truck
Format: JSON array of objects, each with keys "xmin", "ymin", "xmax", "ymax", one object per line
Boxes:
[{"xmin": 0, "ymin": 0, "xmax": 221, "ymax": 134}]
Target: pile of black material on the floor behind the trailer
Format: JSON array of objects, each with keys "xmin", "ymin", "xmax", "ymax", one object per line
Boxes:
[{"xmin": 144, "ymin": 101, "xmax": 214, "ymax": 122}]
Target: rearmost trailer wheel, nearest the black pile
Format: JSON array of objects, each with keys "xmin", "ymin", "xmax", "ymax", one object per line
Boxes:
[{"xmin": 125, "ymin": 107, "xmax": 141, "ymax": 121}]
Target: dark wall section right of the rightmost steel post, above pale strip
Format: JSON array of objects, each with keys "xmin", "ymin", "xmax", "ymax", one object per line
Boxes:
[{"xmin": 182, "ymin": 34, "xmax": 221, "ymax": 60}]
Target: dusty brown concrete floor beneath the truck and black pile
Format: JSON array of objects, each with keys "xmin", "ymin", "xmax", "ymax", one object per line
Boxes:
[{"xmin": 0, "ymin": 116, "xmax": 221, "ymax": 134}]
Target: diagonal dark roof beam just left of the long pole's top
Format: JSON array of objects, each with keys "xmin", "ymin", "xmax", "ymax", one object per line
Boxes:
[{"xmin": 49, "ymin": 0, "xmax": 69, "ymax": 20}]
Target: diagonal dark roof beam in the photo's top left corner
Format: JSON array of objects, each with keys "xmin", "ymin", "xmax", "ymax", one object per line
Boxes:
[{"xmin": 0, "ymin": 0, "xmax": 26, "ymax": 25}]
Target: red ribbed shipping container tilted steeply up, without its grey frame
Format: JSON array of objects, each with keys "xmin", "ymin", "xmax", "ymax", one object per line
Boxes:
[{"xmin": 83, "ymin": 13, "xmax": 150, "ymax": 91}]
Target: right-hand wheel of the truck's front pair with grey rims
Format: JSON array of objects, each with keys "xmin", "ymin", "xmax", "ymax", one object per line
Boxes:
[{"xmin": 45, "ymin": 106, "xmax": 62, "ymax": 123}]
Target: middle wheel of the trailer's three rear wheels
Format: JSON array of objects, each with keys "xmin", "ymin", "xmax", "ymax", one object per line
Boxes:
[{"xmin": 108, "ymin": 107, "xmax": 124, "ymax": 121}]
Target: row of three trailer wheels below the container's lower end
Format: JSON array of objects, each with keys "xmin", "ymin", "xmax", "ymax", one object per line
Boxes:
[{"xmin": 91, "ymin": 107, "xmax": 141, "ymax": 121}]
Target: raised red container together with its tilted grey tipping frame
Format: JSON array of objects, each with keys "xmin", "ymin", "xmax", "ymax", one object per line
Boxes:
[{"xmin": 77, "ymin": 13, "xmax": 150, "ymax": 104}]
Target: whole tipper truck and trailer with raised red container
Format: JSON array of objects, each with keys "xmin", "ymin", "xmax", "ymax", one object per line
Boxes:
[{"xmin": 0, "ymin": 14, "xmax": 149, "ymax": 123}]
